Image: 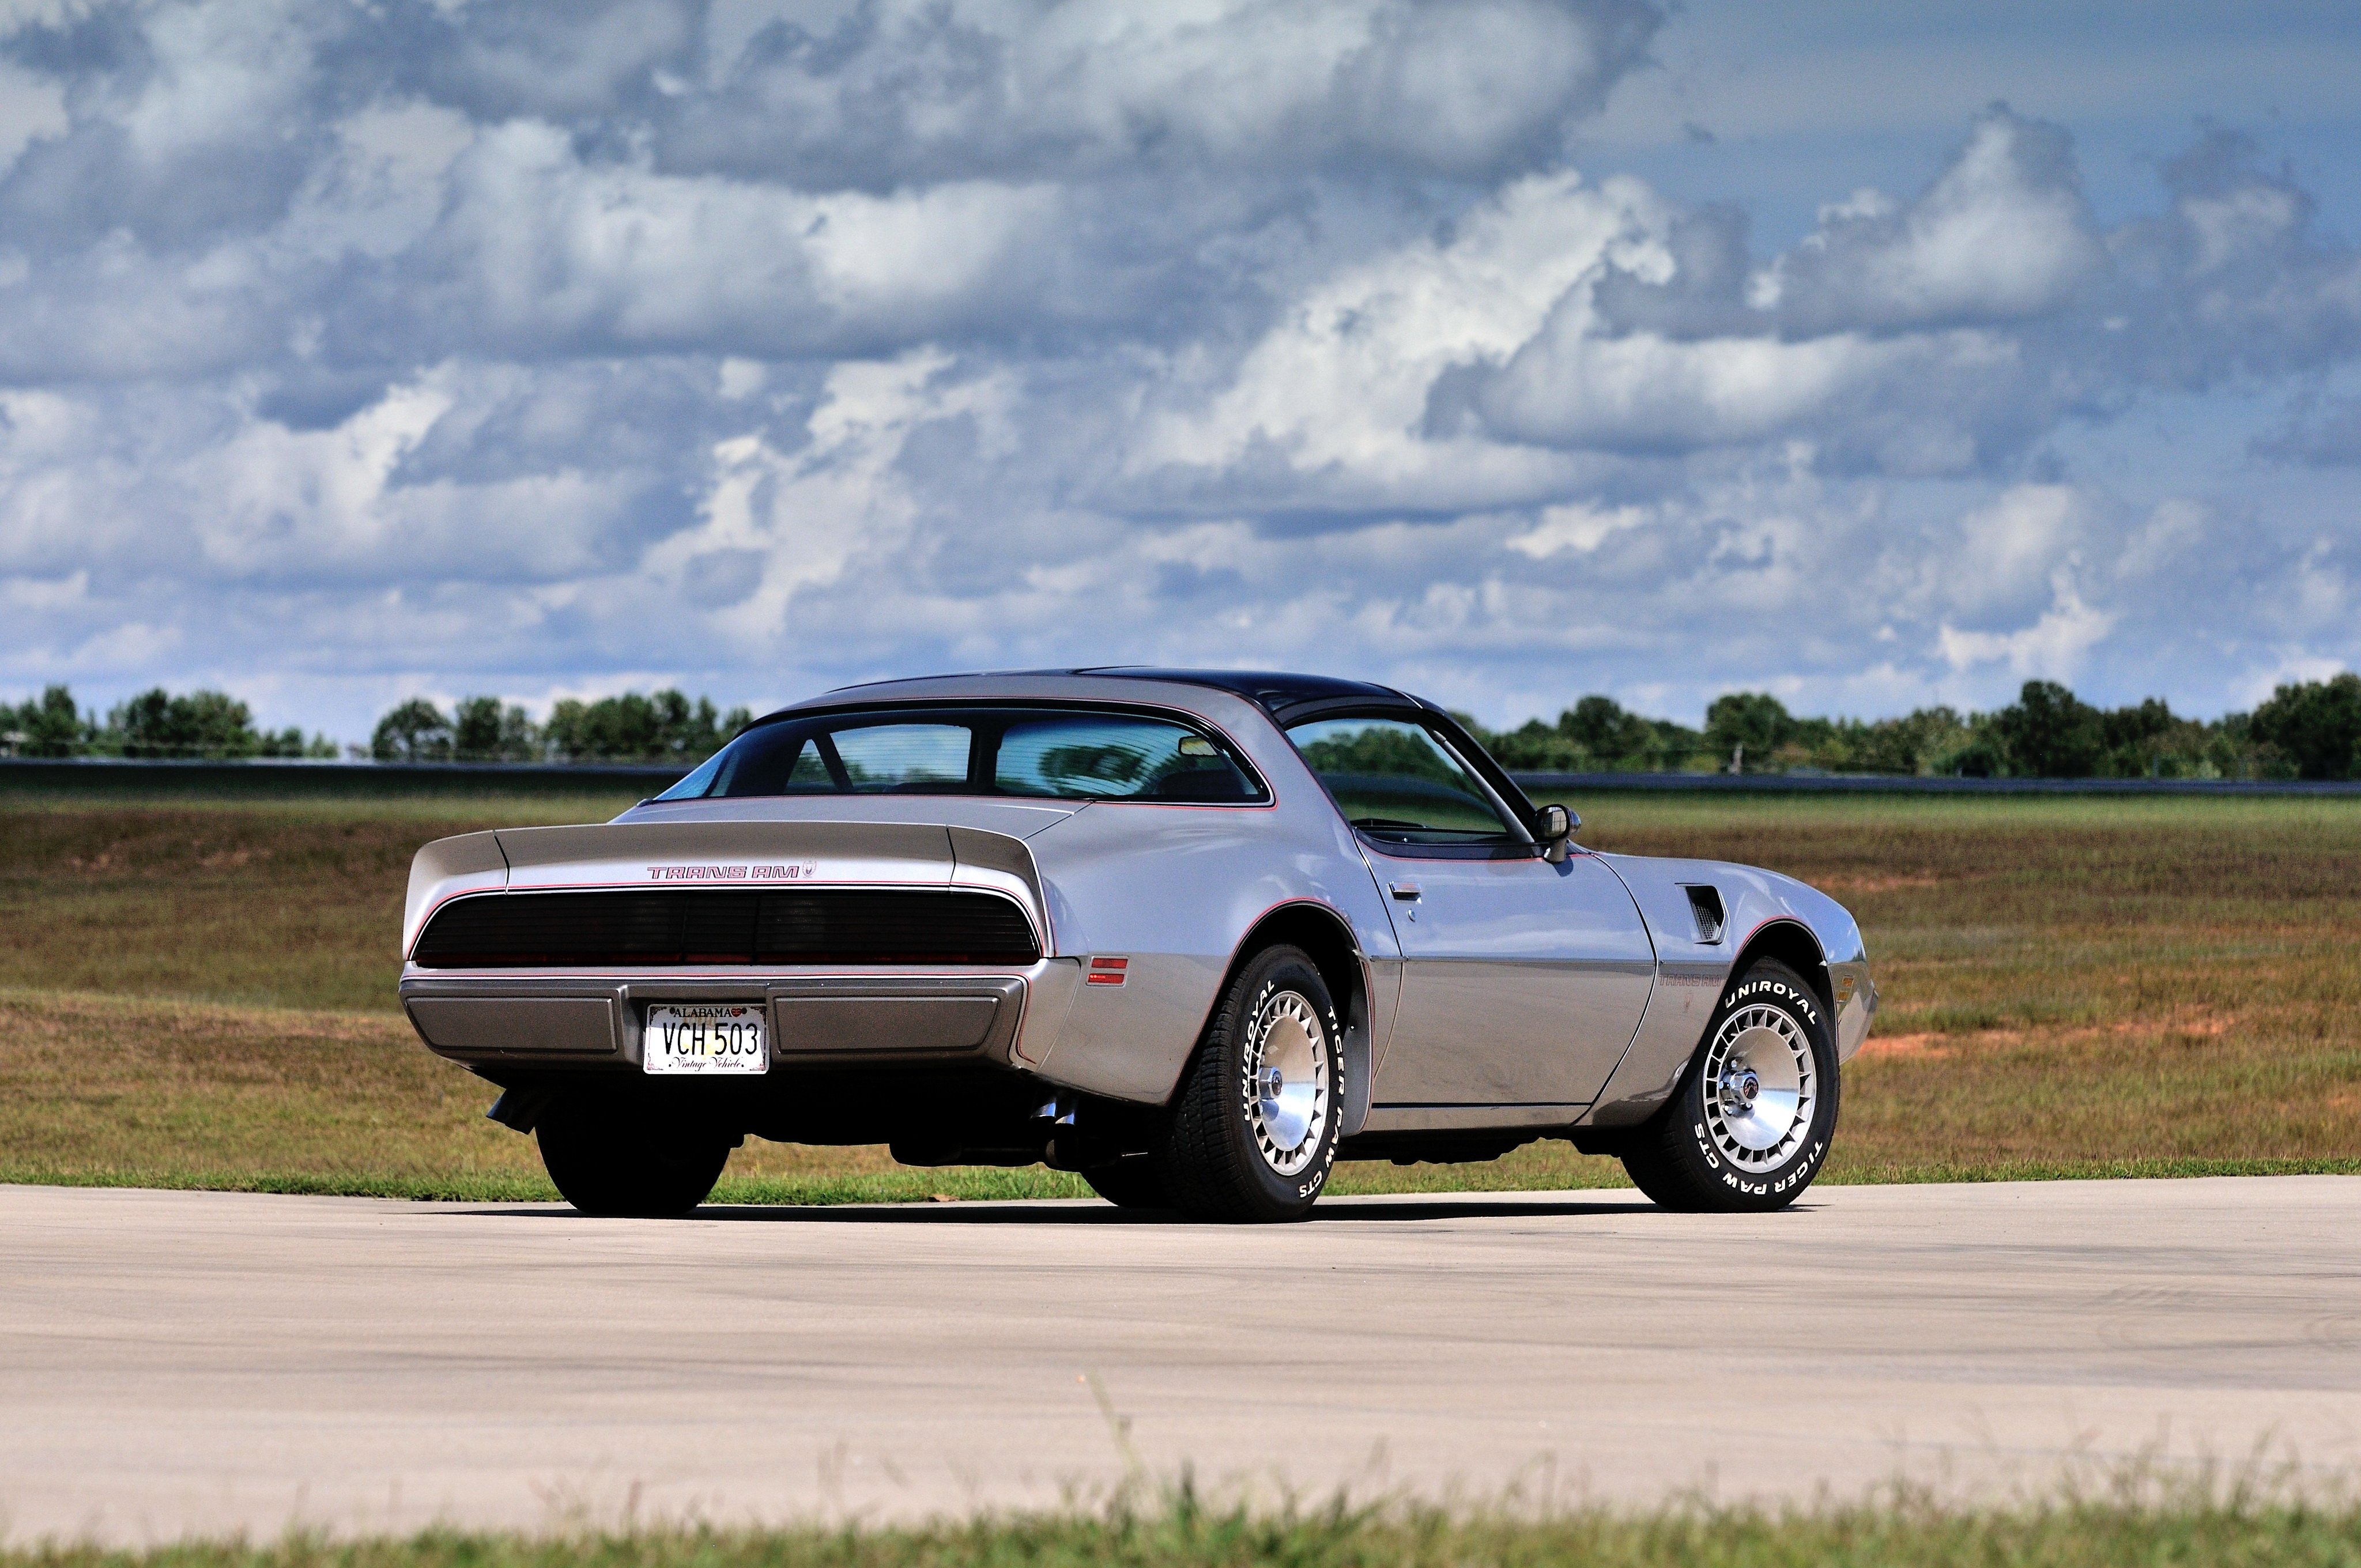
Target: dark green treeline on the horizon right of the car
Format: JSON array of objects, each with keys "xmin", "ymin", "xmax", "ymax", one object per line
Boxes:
[{"xmin": 1471, "ymin": 673, "xmax": 2361, "ymax": 779}]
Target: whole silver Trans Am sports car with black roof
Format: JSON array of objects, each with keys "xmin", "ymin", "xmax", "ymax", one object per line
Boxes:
[{"xmin": 401, "ymin": 668, "xmax": 1877, "ymax": 1219}]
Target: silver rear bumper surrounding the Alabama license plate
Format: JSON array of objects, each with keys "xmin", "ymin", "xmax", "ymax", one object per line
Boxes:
[{"xmin": 401, "ymin": 959, "xmax": 1079, "ymax": 1072}]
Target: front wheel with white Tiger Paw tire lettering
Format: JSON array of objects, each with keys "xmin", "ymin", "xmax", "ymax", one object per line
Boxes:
[{"xmin": 1622, "ymin": 959, "xmax": 1839, "ymax": 1214}]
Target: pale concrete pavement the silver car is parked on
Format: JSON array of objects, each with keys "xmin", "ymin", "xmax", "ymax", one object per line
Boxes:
[{"xmin": 0, "ymin": 1176, "xmax": 2361, "ymax": 1542}]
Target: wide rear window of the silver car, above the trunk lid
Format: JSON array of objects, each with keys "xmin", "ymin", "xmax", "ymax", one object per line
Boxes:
[{"xmin": 657, "ymin": 708, "xmax": 1270, "ymax": 805}]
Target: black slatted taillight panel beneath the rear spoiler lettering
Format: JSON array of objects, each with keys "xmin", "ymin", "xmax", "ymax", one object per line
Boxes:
[{"xmin": 411, "ymin": 890, "xmax": 1041, "ymax": 968}]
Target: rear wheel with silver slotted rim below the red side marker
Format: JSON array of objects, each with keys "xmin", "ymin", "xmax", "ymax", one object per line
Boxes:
[{"xmin": 1159, "ymin": 947, "xmax": 1344, "ymax": 1221}]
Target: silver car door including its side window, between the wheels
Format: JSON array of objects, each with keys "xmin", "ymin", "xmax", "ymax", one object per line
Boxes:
[{"xmin": 1289, "ymin": 718, "xmax": 1655, "ymax": 1105}]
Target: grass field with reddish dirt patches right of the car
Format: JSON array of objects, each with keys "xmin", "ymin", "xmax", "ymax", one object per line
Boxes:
[{"xmin": 1584, "ymin": 798, "xmax": 2361, "ymax": 1178}]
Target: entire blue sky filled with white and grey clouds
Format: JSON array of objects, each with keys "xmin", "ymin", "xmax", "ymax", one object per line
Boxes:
[{"xmin": 0, "ymin": 0, "xmax": 2361, "ymax": 739}]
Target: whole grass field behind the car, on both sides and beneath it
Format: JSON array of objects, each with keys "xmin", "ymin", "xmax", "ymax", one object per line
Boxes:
[{"xmin": 0, "ymin": 796, "xmax": 2361, "ymax": 1202}]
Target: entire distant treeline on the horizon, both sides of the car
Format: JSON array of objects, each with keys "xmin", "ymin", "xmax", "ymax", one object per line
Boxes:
[{"xmin": 14, "ymin": 673, "xmax": 2361, "ymax": 779}]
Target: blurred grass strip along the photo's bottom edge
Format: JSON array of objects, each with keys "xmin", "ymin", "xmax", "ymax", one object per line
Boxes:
[{"xmin": 0, "ymin": 1480, "xmax": 2361, "ymax": 1568}]
